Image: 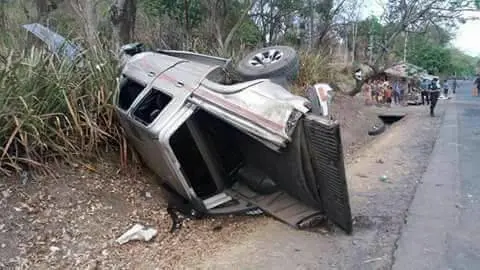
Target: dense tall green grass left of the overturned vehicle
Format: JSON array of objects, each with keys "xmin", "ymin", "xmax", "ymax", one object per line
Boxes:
[{"xmin": 0, "ymin": 36, "xmax": 126, "ymax": 174}]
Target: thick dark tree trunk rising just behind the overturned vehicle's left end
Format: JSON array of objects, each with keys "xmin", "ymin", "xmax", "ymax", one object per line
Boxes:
[{"xmin": 110, "ymin": 0, "xmax": 137, "ymax": 52}]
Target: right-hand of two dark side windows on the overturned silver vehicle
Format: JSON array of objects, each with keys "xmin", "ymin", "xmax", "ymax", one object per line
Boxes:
[{"xmin": 133, "ymin": 89, "xmax": 172, "ymax": 125}]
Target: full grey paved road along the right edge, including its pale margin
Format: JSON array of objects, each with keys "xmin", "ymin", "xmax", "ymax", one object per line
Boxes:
[{"xmin": 393, "ymin": 82, "xmax": 480, "ymax": 270}]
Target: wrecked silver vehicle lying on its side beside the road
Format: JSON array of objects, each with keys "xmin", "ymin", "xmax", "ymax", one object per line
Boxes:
[{"xmin": 116, "ymin": 46, "xmax": 352, "ymax": 233}]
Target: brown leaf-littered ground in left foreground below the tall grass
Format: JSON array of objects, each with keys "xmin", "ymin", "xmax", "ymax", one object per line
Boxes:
[{"xmin": 0, "ymin": 162, "xmax": 264, "ymax": 269}]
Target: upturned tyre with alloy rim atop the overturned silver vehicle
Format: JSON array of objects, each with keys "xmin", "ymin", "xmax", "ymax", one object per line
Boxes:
[{"xmin": 237, "ymin": 46, "xmax": 300, "ymax": 81}]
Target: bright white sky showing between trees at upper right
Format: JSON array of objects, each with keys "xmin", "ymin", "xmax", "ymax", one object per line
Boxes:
[{"xmin": 361, "ymin": 0, "xmax": 480, "ymax": 56}]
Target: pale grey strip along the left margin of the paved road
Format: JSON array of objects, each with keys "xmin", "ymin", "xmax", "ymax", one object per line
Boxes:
[{"xmin": 393, "ymin": 103, "xmax": 460, "ymax": 270}]
